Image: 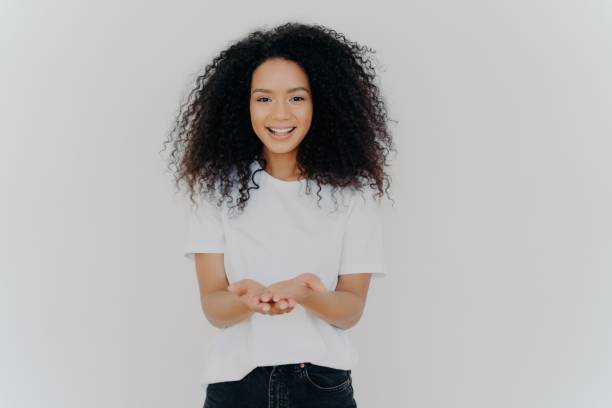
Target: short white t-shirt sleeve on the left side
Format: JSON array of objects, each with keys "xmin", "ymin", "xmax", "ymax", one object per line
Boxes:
[{"xmin": 184, "ymin": 197, "xmax": 225, "ymax": 259}]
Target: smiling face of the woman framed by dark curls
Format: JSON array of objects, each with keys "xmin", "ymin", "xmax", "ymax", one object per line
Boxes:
[{"xmin": 250, "ymin": 58, "xmax": 312, "ymax": 160}]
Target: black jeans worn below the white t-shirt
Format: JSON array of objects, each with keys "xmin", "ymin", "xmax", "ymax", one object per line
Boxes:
[{"xmin": 204, "ymin": 362, "xmax": 357, "ymax": 408}]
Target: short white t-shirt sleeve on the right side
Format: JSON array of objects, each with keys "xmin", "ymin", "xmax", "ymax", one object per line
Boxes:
[{"xmin": 338, "ymin": 189, "xmax": 387, "ymax": 278}]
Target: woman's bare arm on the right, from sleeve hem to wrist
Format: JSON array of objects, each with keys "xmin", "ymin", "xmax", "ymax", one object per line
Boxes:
[{"xmin": 299, "ymin": 273, "xmax": 371, "ymax": 330}]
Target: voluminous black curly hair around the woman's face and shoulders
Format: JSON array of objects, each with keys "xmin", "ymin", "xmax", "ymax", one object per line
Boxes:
[{"xmin": 164, "ymin": 22, "xmax": 395, "ymax": 215}]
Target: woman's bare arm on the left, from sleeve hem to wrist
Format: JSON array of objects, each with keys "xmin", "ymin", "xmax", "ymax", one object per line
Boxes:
[{"xmin": 195, "ymin": 253, "xmax": 254, "ymax": 328}]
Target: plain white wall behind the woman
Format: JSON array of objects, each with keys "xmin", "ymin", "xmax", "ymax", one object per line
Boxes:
[{"xmin": 0, "ymin": 0, "xmax": 612, "ymax": 408}]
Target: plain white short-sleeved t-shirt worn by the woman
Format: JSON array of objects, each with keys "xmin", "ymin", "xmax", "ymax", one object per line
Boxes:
[{"xmin": 184, "ymin": 161, "xmax": 386, "ymax": 386}]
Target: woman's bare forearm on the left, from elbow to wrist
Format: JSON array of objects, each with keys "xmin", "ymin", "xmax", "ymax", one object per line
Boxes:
[{"xmin": 201, "ymin": 290, "xmax": 254, "ymax": 328}]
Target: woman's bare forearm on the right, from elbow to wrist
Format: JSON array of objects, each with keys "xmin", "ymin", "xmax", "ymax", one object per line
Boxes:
[{"xmin": 300, "ymin": 291, "xmax": 364, "ymax": 329}]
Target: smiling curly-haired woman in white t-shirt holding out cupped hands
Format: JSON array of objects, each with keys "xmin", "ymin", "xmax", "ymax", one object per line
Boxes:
[{"xmin": 164, "ymin": 23, "xmax": 393, "ymax": 408}]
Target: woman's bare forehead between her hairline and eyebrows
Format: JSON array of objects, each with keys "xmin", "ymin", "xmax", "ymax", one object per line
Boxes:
[{"xmin": 251, "ymin": 58, "xmax": 308, "ymax": 91}]
